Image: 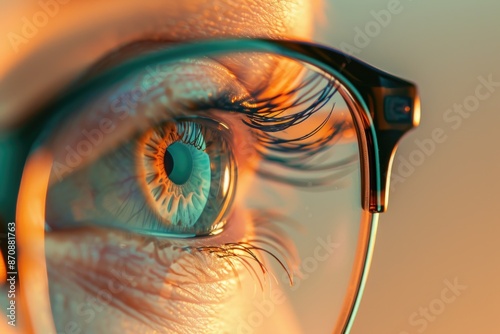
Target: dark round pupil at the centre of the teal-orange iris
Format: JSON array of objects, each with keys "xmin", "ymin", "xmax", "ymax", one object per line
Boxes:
[{"xmin": 163, "ymin": 142, "xmax": 193, "ymax": 185}]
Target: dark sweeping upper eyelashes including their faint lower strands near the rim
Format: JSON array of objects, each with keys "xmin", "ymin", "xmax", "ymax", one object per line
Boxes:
[{"xmin": 197, "ymin": 72, "xmax": 358, "ymax": 189}]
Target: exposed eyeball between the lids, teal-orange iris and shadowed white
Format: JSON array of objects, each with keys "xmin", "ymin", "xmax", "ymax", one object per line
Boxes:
[{"xmin": 47, "ymin": 117, "xmax": 236, "ymax": 237}]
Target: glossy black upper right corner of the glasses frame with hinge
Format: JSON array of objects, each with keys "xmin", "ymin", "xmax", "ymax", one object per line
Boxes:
[{"xmin": 268, "ymin": 41, "xmax": 420, "ymax": 213}]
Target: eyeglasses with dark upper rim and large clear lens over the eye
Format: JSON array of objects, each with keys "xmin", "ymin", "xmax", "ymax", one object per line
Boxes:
[{"xmin": 4, "ymin": 39, "xmax": 420, "ymax": 333}]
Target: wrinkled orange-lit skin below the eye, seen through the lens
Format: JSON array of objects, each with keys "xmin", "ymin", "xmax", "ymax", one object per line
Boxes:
[{"xmin": 46, "ymin": 209, "xmax": 254, "ymax": 333}]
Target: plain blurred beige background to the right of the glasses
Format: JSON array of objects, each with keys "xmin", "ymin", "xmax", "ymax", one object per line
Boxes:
[{"xmin": 316, "ymin": 0, "xmax": 500, "ymax": 334}]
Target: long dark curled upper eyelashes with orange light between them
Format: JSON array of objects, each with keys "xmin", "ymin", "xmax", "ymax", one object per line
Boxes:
[{"xmin": 191, "ymin": 73, "xmax": 352, "ymax": 177}]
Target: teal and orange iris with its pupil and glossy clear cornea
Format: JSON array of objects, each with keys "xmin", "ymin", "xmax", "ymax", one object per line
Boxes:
[{"xmin": 137, "ymin": 118, "xmax": 236, "ymax": 235}]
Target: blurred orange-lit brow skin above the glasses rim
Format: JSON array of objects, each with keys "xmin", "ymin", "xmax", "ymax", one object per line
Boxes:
[{"xmin": 0, "ymin": 0, "xmax": 304, "ymax": 129}]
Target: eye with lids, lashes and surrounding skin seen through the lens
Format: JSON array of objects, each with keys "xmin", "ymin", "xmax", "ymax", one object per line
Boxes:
[{"xmin": 20, "ymin": 40, "xmax": 360, "ymax": 333}]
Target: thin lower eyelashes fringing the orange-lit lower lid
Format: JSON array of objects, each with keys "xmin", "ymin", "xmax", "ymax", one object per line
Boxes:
[{"xmin": 122, "ymin": 209, "xmax": 301, "ymax": 291}]
